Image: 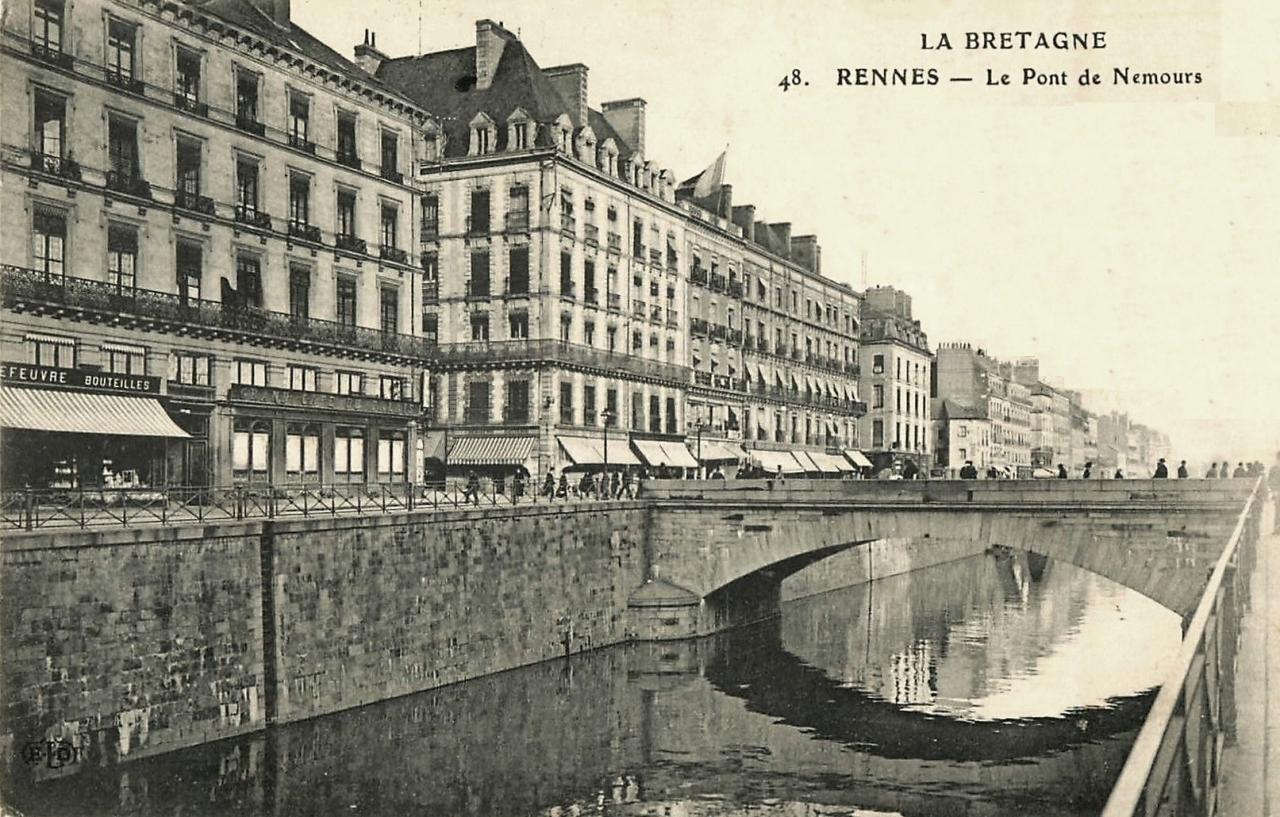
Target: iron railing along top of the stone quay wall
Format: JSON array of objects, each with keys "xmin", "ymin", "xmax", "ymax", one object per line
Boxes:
[{"xmin": 0, "ymin": 479, "xmax": 634, "ymax": 530}]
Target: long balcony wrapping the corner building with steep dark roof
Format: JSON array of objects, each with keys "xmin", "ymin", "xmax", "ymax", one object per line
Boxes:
[{"xmin": 435, "ymin": 339, "xmax": 689, "ymax": 384}]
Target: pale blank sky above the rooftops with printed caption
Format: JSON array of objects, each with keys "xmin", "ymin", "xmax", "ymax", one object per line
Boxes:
[{"xmin": 293, "ymin": 0, "xmax": 1280, "ymax": 462}]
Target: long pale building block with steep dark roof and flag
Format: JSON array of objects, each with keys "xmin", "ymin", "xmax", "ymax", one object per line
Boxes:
[{"xmin": 372, "ymin": 20, "xmax": 856, "ymax": 476}]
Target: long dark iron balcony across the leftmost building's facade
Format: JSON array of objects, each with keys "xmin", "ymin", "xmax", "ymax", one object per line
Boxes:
[{"xmin": 0, "ymin": 265, "xmax": 430, "ymax": 357}]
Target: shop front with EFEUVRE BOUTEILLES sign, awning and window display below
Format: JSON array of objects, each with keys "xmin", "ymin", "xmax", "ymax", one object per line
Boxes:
[{"xmin": 0, "ymin": 362, "xmax": 191, "ymax": 490}]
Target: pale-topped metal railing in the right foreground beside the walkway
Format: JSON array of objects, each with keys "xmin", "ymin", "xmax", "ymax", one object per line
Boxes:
[{"xmin": 1102, "ymin": 478, "xmax": 1262, "ymax": 817}]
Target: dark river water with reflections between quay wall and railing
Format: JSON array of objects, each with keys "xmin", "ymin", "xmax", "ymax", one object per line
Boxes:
[{"xmin": 9, "ymin": 554, "xmax": 1180, "ymax": 817}]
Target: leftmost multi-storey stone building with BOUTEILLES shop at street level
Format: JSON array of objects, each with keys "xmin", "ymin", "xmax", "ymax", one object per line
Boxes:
[{"xmin": 0, "ymin": 0, "xmax": 426, "ymax": 488}]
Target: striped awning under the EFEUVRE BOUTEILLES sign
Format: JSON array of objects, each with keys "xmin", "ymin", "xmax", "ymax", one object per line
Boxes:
[{"xmin": 0, "ymin": 387, "xmax": 191, "ymax": 437}]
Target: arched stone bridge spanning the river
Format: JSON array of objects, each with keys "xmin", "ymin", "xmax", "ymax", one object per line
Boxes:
[{"xmin": 628, "ymin": 480, "xmax": 1252, "ymax": 640}]
